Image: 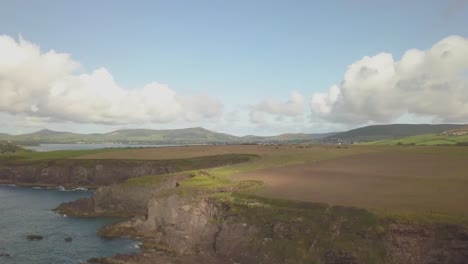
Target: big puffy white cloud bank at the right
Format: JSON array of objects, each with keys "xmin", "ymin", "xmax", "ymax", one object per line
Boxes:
[{"xmin": 311, "ymin": 36, "xmax": 468, "ymax": 124}]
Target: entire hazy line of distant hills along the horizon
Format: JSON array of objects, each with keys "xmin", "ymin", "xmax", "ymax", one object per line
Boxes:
[{"xmin": 0, "ymin": 124, "xmax": 466, "ymax": 144}]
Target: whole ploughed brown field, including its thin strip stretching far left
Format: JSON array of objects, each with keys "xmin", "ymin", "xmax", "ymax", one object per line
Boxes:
[{"xmin": 79, "ymin": 145, "xmax": 468, "ymax": 216}]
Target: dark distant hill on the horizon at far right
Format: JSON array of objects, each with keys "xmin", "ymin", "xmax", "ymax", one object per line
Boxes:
[{"xmin": 323, "ymin": 124, "xmax": 466, "ymax": 143}]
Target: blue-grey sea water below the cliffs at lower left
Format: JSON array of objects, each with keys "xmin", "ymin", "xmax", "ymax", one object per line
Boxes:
[{"xmin": 0, "ymin": 186, "xmax": 139, "ymax": 264}]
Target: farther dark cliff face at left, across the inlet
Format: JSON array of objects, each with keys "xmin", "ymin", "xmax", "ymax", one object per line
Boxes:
[{"xmin": 0, "ymin": 155, "xmax": 255, "ymax": 188}]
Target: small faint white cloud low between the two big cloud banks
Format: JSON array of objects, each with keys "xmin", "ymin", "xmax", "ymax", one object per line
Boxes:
[{"xmin": 250, "ymin": 91, "xmax": 305, "ymax": 123}]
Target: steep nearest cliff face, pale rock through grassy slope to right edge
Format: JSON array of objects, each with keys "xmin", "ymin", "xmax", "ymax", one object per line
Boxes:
[{"xmin": 90, "ymin": 190, "xmax": 468, "ymax": 264}]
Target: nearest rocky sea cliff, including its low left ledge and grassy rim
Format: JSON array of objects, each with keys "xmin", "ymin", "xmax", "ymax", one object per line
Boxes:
[{"xmin": 58, "ymin": 171, "xmax": 468, "ymax": 264}]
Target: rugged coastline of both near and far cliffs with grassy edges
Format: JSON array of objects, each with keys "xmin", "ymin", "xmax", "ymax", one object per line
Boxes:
[{"xmin": 0, "ymin": 148, "xmax": 468, "ymax": 264}]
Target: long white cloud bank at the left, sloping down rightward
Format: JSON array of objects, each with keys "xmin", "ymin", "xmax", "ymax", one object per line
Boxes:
[{"xmin": 0, "ymin": 35, "xmax": 223, "ymax": 124}]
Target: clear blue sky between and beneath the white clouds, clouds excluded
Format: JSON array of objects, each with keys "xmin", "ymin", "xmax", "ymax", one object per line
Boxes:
[{"xmin": 0, "ymin": 0, "xmax": 468, "ymax": 134}]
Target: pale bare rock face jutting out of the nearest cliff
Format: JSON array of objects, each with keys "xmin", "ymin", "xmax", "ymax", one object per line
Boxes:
[{"xmin": 97, "ymin": 194, "xmax": 266, "ymax": 263}]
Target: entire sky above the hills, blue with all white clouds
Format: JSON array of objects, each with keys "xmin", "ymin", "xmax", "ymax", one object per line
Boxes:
[{"xmin": 0, "ymin": 0, "xmax": 468, "ymax": 135}]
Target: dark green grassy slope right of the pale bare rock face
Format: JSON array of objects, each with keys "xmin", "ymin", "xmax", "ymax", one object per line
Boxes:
[{"xmin": 210, "ymin": 192, "xmax": 385, "ymax": 263}]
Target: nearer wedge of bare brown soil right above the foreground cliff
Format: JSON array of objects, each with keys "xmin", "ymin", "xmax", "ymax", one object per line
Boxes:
[{"xmin": 233, "ymin": 152, "xmax": 468, "ymax": 215}]
